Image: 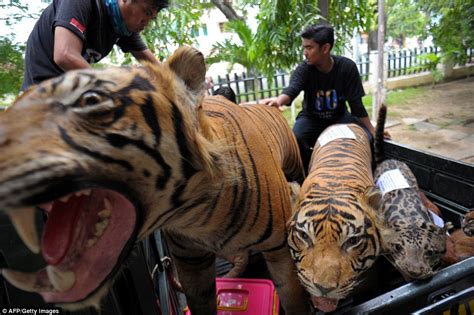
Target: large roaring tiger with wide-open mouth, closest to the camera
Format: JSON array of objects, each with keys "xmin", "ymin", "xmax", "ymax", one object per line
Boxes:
[{"xmin": 0, "ymin": 46, "xmax": 311, "ymax": 315}]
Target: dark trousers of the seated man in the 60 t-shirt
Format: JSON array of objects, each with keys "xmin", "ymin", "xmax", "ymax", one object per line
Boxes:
[{"xmin": 293, "ymin": 112, "xmax": 373, "ymax": 174}]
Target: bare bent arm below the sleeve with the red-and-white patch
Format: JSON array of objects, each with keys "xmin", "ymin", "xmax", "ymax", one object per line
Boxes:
[{"xmin": 53, "ymin": 26, "xmax": 90, "ymax": 71}]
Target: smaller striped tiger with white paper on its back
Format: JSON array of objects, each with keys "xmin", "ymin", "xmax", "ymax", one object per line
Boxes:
[{"xmin": 288, "ymin": 124, "xmax": 381, "ymax": 312}]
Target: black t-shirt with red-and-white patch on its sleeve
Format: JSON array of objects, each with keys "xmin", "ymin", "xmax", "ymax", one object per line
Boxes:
[{"xmin": 22, "ymin": 0, "xmax": 147, "ymax": 90}]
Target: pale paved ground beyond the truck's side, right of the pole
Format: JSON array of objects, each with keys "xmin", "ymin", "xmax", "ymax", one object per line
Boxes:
[{"xmin": 386, "ymin": 77, "xmax": 474, "ymax": 165}]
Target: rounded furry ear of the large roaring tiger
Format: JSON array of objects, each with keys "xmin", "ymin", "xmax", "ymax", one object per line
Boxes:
[{"xmin": 166, "ymin": 46, "xmax": 206, "ymax": 94}]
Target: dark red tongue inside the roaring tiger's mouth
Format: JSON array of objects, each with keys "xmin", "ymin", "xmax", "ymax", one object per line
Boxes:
[{"xmin": 41, "ymin": 196, "xmax": 83, "ymax": 265}]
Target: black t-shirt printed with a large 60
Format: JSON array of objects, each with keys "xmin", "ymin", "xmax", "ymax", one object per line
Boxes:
[{"xmin": 283, "ymin": 56, "xmax": 368, "ymax": 121}]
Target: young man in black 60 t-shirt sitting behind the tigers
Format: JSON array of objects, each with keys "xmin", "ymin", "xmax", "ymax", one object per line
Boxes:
[{"xmin": 266, "ymin": 25, "xmax": 390, "ymax": 171}]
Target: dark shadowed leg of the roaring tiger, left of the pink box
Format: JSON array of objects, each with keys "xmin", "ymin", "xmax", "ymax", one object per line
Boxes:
[{"xmin": 165, "ymin": 233, "xmax": 217, "ymax": 315}]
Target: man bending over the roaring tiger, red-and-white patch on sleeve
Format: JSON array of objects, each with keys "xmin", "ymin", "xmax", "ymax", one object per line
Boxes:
[{"xmin": 21, "ymin": 0, "xmax": 168, "ymax": 90}]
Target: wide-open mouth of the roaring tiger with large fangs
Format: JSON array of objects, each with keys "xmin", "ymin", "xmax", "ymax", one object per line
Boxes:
[{"xmin": 1, "ymin": 189, "xmax": 137, "ymax": 303}]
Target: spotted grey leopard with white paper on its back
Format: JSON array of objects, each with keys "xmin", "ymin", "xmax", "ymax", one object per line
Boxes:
[{"xmin": 374, "ymin": 105, "xmax": 451, "ymax": 281}]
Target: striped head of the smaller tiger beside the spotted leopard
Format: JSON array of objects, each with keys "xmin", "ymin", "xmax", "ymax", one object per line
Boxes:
[{"xmin": 288, "ymin": 183, "xmax": 381, "ymax": 312}]
